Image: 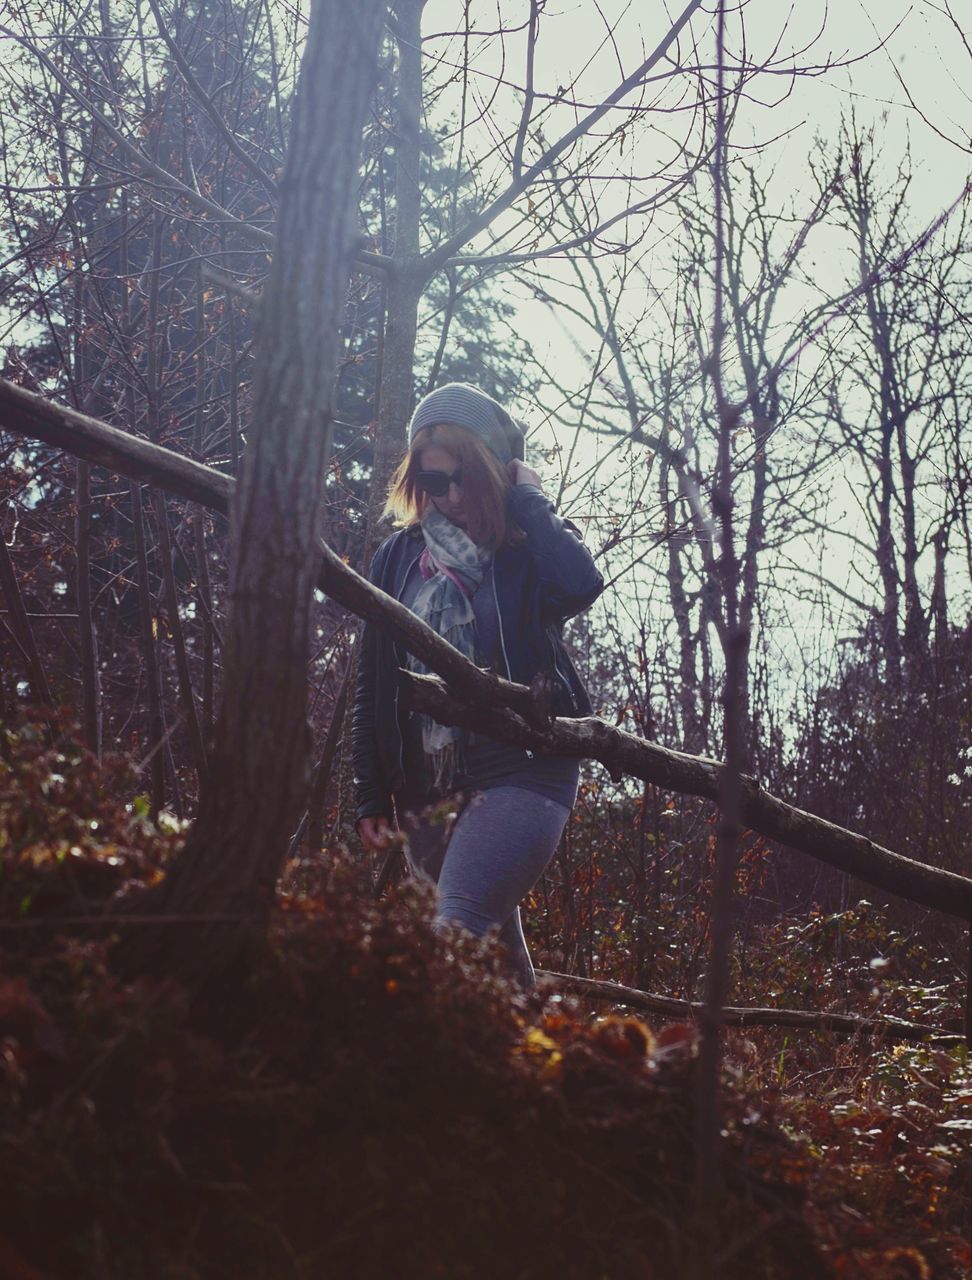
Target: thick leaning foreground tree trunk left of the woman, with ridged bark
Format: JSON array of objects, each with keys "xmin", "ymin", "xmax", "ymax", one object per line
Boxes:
[{"xmin": 123, "ymin": 0, "xmax": 384, "ymax": 979}]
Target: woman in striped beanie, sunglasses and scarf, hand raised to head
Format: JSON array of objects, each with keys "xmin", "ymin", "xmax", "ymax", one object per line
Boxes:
[{"xmin": 352, "ymin": 383, "xmax": 603, "ymax": 988}]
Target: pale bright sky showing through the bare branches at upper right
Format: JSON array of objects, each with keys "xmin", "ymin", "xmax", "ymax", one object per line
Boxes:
[{"xmin": 423, "ymin": 0, "xmax": 972, "ymax": 706}]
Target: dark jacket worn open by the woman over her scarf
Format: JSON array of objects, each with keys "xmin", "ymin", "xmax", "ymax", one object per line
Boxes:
[{"xmin": 351, "ymin": 485, "xmax": 604, "ymax": 819}]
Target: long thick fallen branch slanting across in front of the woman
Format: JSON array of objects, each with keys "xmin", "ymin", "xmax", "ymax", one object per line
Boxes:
[{"xmin": 0, "ymin": 379, "xmax": 972, "ymax": 920}]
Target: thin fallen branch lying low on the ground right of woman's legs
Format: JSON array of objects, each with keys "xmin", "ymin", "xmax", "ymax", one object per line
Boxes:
[{"xmin": 537, "ymin": 969, "xmax": 964, "ymax": 1044}]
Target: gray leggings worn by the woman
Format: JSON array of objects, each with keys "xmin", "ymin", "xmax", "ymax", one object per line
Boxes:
[{"xmin": 409, "ymin": 787, "xmax": 570, "ymax": 989}]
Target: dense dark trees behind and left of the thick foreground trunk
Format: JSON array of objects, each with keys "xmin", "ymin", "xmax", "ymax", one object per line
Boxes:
[{"xmin": 0, "ymin": 0, "xmax": 548, "ymax": 815}]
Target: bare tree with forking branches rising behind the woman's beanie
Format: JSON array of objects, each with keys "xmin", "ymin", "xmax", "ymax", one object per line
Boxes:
[{"xmin": 353, "ymin": 0, "xmax": 699, "ymax": 568}]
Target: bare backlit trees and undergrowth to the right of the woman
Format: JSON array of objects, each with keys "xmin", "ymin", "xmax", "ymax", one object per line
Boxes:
[{"xmin": 512, "ymin": 120, "xmax": 972, "ymax": 972}]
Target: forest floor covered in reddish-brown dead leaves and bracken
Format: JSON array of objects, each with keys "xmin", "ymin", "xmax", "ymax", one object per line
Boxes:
[{"xmin": 0, "ymin": 724, "xmax": 972, "ymax": 1280}]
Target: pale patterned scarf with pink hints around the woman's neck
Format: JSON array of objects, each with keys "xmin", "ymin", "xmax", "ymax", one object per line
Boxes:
[{"xmin": 409, "ymin": 503, "xmax": 493, "ymax": 794}]
